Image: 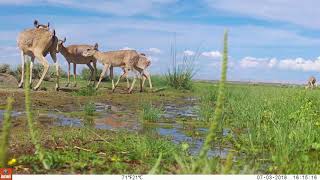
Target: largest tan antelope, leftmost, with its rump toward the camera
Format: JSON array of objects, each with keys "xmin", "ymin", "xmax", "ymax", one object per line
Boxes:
[{"xmin": 17, "ymin": 20, "xmax": 59, "ymax": 90}]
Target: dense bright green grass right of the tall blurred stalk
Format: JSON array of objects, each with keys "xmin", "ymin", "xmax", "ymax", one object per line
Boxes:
[{"xmin": 225, "ymin": 86, "xmax": 320, "ymax": 174}]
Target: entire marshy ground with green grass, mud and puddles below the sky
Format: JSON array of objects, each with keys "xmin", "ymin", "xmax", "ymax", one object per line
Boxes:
[{"xmin": 0, "ymin": 33, "xmax": 320, "ymax": 174}]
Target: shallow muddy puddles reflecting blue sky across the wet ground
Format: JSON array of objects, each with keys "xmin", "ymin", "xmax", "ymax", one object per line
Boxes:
[{"xmin": 0, "ymin": 99, "xmax": 229, "ymax": 158}]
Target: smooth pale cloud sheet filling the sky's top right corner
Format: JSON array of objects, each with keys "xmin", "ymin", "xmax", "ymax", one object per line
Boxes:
[{"xmin": 205, "ymin": 0, "xmax": 320, "ymax": 29}]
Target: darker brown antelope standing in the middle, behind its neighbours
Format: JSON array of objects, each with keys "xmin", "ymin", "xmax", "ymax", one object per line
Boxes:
[{"xmin": 57, "ymin": 38, "xmax": 98, "ymax": 86}]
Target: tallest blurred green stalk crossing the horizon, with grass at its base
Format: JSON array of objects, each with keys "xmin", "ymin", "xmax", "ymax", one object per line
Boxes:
[{"xmin": 175, "ymin": 31, "xmax": 233, "ymax": 174}]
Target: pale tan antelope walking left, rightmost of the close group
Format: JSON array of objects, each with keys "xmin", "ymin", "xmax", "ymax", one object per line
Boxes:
[{"xmin": 83, "ymin": 49, "xmax": 152, "ymax": 93}]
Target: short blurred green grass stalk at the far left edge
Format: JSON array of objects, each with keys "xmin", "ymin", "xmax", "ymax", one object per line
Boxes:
[{"xmin": 0, "ymin": 97, "xmax": 13, "ymax": 167}]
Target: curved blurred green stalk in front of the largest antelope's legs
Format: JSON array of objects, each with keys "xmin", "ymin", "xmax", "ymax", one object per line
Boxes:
[{"xmin": 24, "ymin": 62, "xmax": 50, "ymax": 169}]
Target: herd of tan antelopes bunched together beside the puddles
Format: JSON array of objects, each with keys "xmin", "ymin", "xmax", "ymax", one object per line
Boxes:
[{"xmin": 17, "ymin": 20, "xmax": 152, "ymax": 93}]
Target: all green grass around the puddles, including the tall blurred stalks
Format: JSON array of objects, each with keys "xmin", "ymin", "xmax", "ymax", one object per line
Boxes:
[{"xmin": 1, "ymin": 29, "xmax": 320, "ymax": 174}]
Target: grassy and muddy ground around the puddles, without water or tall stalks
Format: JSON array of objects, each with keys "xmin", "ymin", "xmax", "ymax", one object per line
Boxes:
[{"xmin": 0, "ymin": 77, "xmax": 320, "ymax": 174}]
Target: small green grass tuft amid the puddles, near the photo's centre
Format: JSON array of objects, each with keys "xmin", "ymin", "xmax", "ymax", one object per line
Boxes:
[{"xmin": 141, "ymin": 103, "xmax": 162, "ymax": 122}]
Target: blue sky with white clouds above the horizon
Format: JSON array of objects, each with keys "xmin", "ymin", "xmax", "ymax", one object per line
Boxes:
[{"xmin": 0, "ymin": 0, "xmax": 320, "ymax": 83}]
